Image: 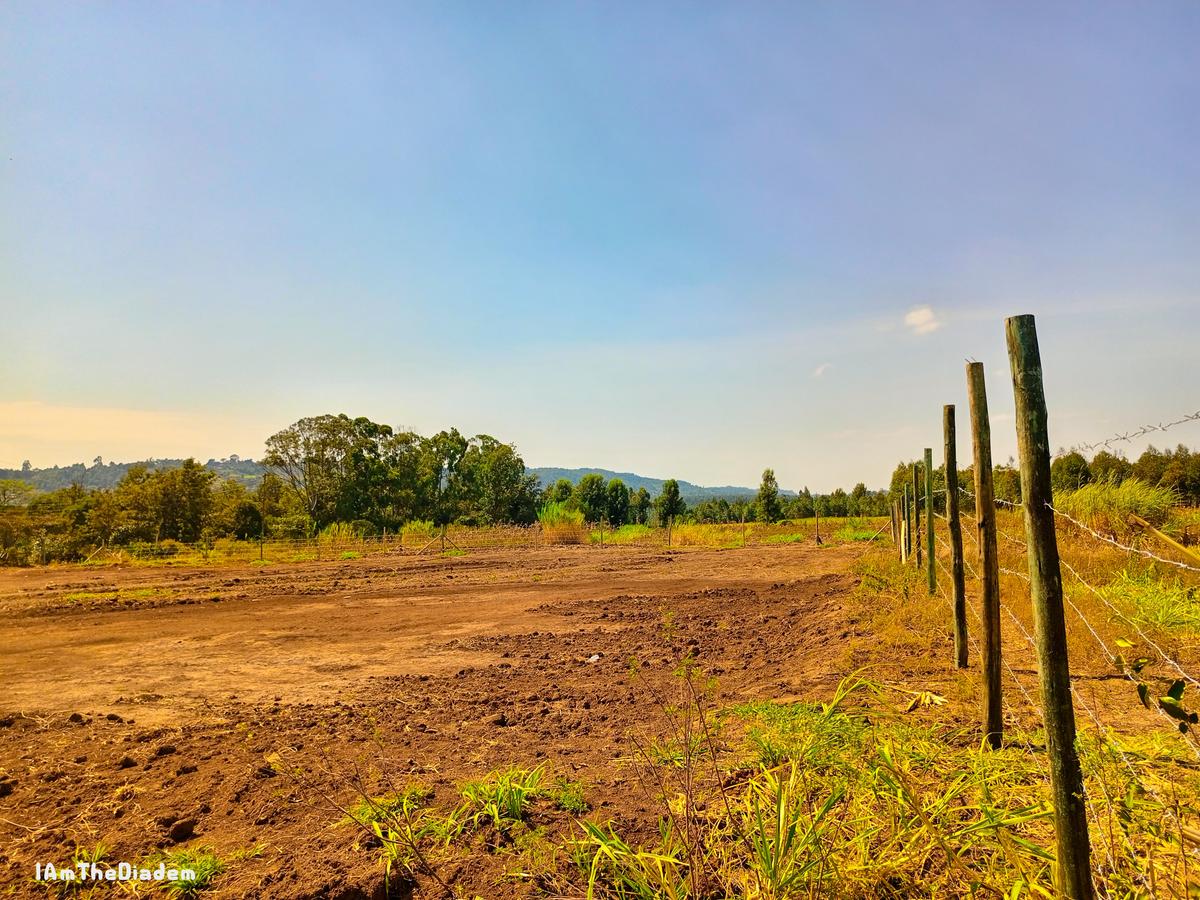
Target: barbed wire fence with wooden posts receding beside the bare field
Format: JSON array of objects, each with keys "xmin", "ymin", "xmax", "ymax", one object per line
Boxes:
[{"xmin": 893, "ymin": 336, "xmax": 1200, "ymax": 898}]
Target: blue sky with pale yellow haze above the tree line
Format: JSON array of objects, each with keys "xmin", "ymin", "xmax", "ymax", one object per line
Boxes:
[{"xmin": 0, "ymin": 2, "xmax": 1200, "ymax": 490}]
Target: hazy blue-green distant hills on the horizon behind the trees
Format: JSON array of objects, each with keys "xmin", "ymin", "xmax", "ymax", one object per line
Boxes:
[{"xmin": 7, "ymin": 456, "xmax": 794, "ymax": 504}]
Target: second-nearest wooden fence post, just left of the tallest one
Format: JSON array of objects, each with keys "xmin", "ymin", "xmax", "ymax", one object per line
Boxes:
[{"xmin": 967, "ymin": 362, "xmax": 1004, "ymax": 750}]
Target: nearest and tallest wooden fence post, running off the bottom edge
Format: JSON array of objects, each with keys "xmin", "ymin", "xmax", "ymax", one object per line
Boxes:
[{"xmin": 1004, "ymin": 316, "xmax": 1094, "ymax": 900}]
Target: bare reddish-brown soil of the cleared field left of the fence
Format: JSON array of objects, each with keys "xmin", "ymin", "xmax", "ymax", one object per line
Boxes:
[{"xmin": 0, "ymin": 545, "xmax": 860, "ymax": 899}]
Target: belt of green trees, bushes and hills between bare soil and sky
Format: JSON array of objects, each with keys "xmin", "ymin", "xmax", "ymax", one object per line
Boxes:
[{"xmin": 0, "ymin": 415, "xmax": 1200, "ymax": 564}]
